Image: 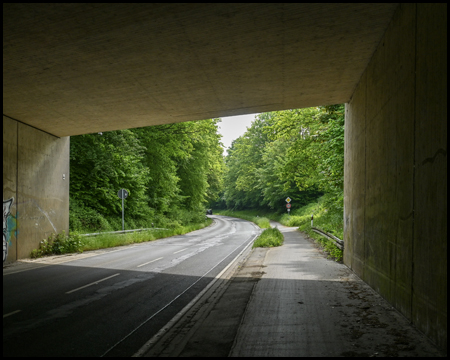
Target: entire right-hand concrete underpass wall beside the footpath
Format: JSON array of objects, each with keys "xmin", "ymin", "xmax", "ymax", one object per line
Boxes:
[{"xmin": 344, "ymin": 4, "xmax": 447, "ymax": 350}]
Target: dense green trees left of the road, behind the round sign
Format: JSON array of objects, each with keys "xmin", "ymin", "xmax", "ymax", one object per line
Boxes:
[{"xmin": 69, "ymin": 119, "xmax": 225, "ymax": 232}]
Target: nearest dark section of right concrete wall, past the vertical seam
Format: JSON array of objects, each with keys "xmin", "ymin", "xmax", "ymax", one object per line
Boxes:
[{"xmin": 412, "ymin": 4, "xmax": 447, "ymax": 347}]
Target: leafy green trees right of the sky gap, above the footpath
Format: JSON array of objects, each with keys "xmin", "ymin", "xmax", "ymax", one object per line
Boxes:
[{"xmin": 223, "ymin": 105, "xmax": 344, "ymax": 214}]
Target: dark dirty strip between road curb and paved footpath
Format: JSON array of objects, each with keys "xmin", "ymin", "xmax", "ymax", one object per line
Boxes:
[{"xmin": 142, "ymin": 248, "xmax": 267, "ymax": 357}]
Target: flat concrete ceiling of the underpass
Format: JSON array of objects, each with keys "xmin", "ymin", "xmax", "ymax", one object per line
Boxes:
[{"xmin": 3, "ymin": 4, "xmax": 397, "ymax": 136}]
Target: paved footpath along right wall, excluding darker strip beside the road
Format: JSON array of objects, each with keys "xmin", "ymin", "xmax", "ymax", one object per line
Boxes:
[{"xmin": 230, "ymin": 224, "xmax": 440, "ymax": 357}]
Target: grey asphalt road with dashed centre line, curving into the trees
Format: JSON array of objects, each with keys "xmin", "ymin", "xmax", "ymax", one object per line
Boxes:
[{"xmin": 3, "ymin": 216, "xmax": 259, "ymax": 356}]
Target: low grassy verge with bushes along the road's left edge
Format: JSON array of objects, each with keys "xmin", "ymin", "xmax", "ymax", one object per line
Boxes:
[{"xmin": 30, "ymin": 219, "xmax": 212, "ymax": 258}]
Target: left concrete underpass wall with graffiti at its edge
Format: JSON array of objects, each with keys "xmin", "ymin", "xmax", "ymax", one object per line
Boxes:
[{"xmin": 3, "ymin": 116, "xmax": 70, "ymax": 263}]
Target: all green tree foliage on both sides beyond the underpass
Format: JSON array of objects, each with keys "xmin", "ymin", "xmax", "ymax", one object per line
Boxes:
[{"xmin": 70, "ymin": 105, "xmax": 344, "ymax": 230}]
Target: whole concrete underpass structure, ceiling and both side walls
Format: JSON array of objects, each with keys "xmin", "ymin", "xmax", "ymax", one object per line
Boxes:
[{"xmin": 3, "ymin": 4, "xmax": 447, "ymax": 350}]
